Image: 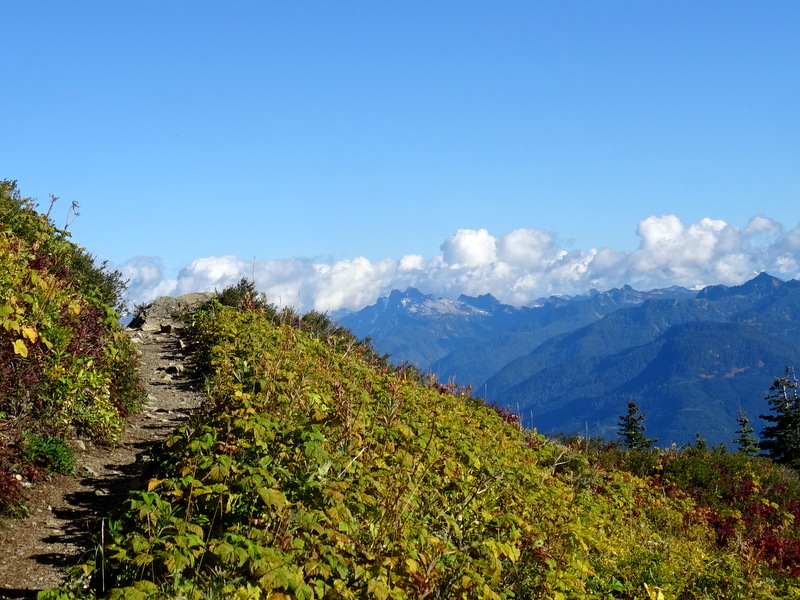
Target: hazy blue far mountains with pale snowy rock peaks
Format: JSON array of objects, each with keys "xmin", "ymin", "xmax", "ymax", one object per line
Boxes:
[{"xmin": 339, "ymin": 286, "xmax": 693, "ymax": 389}]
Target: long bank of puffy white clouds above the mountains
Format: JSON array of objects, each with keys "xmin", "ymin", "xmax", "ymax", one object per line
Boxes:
[{"xmin": 120, "ymin": 215, "xmax": 800, "ymax": 312}]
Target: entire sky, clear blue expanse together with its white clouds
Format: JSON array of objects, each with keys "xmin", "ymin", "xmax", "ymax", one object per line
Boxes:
[{"xmin": 0, "ymin": 1, "xmax": 800, "ymax": 309}]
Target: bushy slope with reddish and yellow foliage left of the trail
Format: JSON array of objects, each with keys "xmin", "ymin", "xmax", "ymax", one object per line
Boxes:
[{"xmin": 0, "ymin": 181, "xmax": 142, "ymax": 513}]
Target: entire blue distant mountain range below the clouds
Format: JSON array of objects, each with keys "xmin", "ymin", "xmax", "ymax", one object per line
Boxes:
[{"xmin": 337, "ymin": 273, "xmax": 800, "ymax": 447}]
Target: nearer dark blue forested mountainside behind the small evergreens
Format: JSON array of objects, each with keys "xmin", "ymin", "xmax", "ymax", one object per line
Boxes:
[{"xmin": 485, "ymin": 274, "xmax": 800, "ymax": 444}]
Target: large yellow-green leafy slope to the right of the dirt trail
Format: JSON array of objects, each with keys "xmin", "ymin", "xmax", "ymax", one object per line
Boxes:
[{"xmin": 42, "ymin": 303, "xmax": 800, "ymax": 600}]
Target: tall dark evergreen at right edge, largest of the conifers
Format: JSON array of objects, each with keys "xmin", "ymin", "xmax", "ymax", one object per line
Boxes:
[{"xmin": 760, "ymin": 367, "xmax": 800, "ymax": 469}]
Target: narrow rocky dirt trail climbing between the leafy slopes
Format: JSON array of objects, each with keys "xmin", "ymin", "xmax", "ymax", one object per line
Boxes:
[{"xmin": 0, "ymin": 327, "xmax": 203, "ymax": 600}]
